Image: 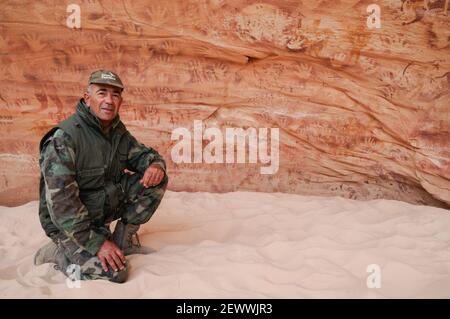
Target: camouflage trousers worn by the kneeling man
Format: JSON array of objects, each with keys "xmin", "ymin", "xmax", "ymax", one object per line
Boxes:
[{"xmin": 53, "ymin": 174, "xmax": 168, "ymax": 282}]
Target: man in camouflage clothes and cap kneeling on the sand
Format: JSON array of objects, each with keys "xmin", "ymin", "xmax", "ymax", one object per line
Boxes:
[{"xmin": 34, "ymin": 70, "xmax": 168, "ymax": 282}]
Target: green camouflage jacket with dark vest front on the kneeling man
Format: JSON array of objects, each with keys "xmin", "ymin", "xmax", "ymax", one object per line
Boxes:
[{"xmin": 39, "ymin": 99, "xmax": 166, "ymax": 255}]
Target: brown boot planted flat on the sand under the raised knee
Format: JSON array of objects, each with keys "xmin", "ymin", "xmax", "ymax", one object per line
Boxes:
[{"xmin": 112, "ymin": 221, "xmax": 154, "ymax": 256}]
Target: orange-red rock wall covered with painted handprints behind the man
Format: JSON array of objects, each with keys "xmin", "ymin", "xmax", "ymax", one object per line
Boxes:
[{"xmin": 0, "ymin": 0, "xmax": 450, "ymax": 207}]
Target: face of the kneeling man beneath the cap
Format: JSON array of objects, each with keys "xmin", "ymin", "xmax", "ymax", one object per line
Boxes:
[{"xmin": 84, "ymin": 84, "xmax": 122, "ymax": 125}]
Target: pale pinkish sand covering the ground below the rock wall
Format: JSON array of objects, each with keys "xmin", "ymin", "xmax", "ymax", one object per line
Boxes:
[{"xmin": 0, "ymin": 192, "xmax": 450, "ymax": 298}]
